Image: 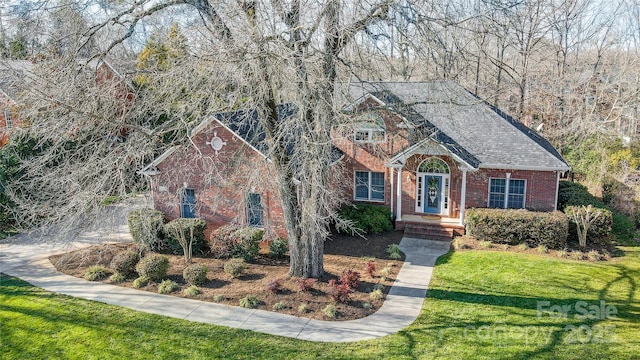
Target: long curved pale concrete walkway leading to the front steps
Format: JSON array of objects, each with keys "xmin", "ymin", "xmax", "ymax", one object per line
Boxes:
[{"xmin": 0, "ymin": 207, "xmax": 449, "ymax": 342}]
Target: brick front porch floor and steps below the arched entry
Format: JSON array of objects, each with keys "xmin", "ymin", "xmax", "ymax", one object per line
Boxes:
[{"xmin": 395, "ymin": 215, "xmax": 464, "ymax": 241}]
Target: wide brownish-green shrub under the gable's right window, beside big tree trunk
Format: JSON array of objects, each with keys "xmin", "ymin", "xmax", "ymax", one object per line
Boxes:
[{"xmin": 209, "ymin": 225, "xmax": 263, "ymax": 262}]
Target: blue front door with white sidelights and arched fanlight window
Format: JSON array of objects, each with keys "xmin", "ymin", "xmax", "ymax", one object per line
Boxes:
[{"xmin": 416, "ymin": 157, "xmax": 451, "ymax": 215}]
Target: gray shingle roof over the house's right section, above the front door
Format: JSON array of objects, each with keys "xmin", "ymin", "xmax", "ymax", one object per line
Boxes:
[{"xmin": 350, "ymin": 81, "xmax": 569, "ymax": 171}]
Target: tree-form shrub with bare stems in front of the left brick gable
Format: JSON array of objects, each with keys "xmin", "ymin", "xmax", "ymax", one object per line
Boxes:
[{"xmin": 164, "ymin": 218, "xmax": 207, "ymax": 261}]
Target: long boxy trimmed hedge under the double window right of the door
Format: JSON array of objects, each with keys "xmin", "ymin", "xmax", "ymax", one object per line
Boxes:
[{"xmin": 466, "ymin": 209, "xmax": 568, "ymax": 249}]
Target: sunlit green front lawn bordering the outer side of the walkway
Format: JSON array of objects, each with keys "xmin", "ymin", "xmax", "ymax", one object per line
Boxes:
[{"xmin": 0, "ymin": 248, "xmax": 640, "ymax": 359}]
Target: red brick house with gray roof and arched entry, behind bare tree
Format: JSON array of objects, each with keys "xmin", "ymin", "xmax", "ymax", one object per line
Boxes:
[{"xmin": 143, "ymin": 81, "xmax": 569, "ymax": 238}]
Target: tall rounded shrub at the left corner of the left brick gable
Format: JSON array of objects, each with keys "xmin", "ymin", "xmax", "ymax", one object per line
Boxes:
[{"xmin": 127, "ymin": 209, "xmax": 166, "ymax": 251}]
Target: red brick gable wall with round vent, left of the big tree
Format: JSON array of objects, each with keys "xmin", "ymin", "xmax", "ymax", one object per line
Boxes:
[{"xmin": 152, "ymin": 121, "xmax": 287, "ymax": 237}]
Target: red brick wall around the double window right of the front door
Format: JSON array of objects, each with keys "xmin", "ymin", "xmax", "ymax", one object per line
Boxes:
[{"xmin": 466, "ymin": 169, "xmax": 557, "ymax": 211}]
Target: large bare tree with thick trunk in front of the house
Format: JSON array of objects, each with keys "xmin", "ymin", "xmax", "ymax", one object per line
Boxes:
[{"xmin": 7, "ymin": 0, "xmax": 391, "ymax": 277}]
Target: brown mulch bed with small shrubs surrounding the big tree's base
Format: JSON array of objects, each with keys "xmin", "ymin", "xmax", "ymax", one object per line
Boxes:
[{"xmin": 49, "ymin": 231, "xmax": 402, "ymax": 320}]
